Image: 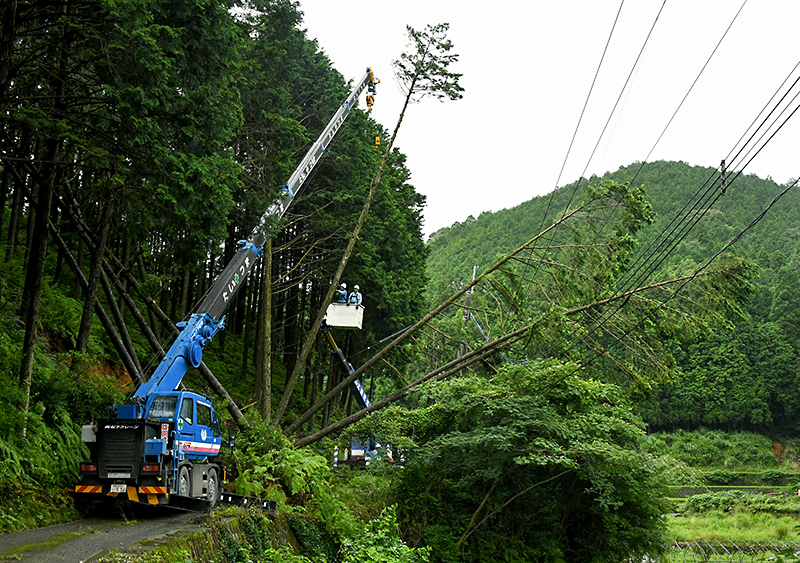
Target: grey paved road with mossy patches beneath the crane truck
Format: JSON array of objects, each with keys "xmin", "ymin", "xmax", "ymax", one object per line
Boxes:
[{"xmin": 0, "ymin": 508, "xmax": 206, "ymax": 563}]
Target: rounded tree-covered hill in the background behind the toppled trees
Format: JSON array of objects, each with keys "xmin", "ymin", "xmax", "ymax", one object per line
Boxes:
[{"xmin": 428, "ymin": 162, "xmax": 800, "ymax": 435}]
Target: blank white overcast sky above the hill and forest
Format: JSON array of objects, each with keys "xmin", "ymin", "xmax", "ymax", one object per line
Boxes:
[{"xmin": 300, "ymin": 0, "xmax": 800, "ymax": 238}]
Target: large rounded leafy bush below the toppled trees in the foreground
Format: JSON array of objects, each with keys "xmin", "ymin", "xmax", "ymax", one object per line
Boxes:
[{"xmin": 395, "ymin": 362, "xmax": 673, "ymax": 561}]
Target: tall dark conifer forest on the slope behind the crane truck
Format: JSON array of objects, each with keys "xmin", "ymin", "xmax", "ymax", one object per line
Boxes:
[{"xmin": 0, "ymin": 0, "xmax": 426, "ymax": 502}]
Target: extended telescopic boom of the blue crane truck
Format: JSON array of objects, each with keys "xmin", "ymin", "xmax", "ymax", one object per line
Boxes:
[{"xmin": 133, "ymin": 68, "xmax": 379, "ymax": 403}]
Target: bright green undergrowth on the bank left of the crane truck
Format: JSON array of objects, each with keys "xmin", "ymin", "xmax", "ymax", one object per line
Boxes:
[{"xmin": 0, "ymin": 249, "xmax": 121, "ymax": 504}]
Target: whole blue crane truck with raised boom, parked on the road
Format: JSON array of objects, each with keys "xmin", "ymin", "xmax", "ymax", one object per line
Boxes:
[{"xmin": 75, "ymin": 68, "xmax": 379, "ymax": 510}]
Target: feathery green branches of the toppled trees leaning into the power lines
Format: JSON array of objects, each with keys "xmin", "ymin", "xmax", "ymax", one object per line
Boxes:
[{"xmin": 424, "ymin": 179, "xmax": 754, "ymax": 406}]
